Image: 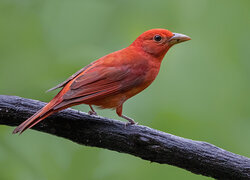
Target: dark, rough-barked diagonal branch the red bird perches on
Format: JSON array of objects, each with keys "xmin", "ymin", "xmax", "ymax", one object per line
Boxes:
[{"xmin": 0, "ymin": 95, "xmax": 250, "ymax": 179}]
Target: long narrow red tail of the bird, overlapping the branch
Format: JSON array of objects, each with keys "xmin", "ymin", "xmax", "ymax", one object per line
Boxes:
[{"xmin": 13, "ymin": 99, "xmax": 61, "ymax": 134}]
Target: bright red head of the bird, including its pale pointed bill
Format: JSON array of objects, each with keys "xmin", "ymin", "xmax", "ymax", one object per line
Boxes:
[{"xmin": 131, "ymin": 29, "xmax": 191, "ymax": 57}]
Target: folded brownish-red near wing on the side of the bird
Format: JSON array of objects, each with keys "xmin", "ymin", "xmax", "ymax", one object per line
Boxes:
[{"xmin": 54, "ymin": 67, "xmax": 144, "ymax": 109}]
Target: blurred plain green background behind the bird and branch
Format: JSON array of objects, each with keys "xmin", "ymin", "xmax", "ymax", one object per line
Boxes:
[{"xmin": 0, "ymin": 0, "xmax": 250, "ymax": 180}]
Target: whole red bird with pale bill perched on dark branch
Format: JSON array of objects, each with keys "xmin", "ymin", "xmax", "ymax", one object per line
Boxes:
[{"xmin": 13, "ymin": 29, "xmax": 190, "ymax": 134}]
